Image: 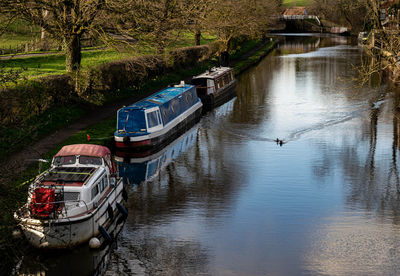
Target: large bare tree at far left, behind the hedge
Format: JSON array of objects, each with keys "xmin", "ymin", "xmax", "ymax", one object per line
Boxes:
[{"xmin": 0, "ymin": 0, "xmax": 106, "ymax": 72}]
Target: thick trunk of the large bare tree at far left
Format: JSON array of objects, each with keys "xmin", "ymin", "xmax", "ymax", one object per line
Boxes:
[{"xmin": 64, "ymin": 35, "xmax": 82, "ymax": 72}]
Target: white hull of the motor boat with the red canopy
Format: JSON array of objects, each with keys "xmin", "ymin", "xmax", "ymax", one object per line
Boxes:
[{"xmin": 14, "ymin": 179, "xmax": 125, "ymax": 249}]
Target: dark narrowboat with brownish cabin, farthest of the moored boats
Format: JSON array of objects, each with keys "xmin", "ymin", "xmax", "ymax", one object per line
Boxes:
[{"xmin": 192, "ymin": 67, "xmax": 236, "ymax": 110}]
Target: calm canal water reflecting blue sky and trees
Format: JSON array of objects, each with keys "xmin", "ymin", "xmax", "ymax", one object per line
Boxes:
[{"xmin": 107, "ymin": 35, "xmax": 400, "ymax": 275}]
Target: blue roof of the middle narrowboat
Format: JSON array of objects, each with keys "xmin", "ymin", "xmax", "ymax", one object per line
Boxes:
[{"xmin": 124, "ymin": 84, "xmax": 194, "ymax": 109}]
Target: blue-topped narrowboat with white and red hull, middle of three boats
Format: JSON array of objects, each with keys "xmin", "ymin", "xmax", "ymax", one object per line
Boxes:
[{"xmin": 114, "ymin": 82, "xmax": 203, "ymax": 151}]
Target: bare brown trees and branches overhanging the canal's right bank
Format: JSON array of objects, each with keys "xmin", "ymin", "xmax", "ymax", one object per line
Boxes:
[{"xmin": 311, "ymin": 0, "xmax": 400, "ymax": 85}]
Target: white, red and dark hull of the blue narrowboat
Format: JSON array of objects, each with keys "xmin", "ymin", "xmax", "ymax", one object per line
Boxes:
[{"xmin": 114, "ymin": 101, "xmax": 202, "ymax": 152}]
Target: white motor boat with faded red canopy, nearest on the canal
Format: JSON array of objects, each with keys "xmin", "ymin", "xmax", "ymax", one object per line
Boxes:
[{"xmin": 14, "ymin": 144, "xmax": 128, "ymax": 248}]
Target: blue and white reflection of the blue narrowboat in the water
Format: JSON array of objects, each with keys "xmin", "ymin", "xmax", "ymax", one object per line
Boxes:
[{"xmin": 114, "ymin": 124, "xmax": 199, "ymax": 185}]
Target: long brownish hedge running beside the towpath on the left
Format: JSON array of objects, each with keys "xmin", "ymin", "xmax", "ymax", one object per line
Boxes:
[{"xmin": 0, "ymin": 42, "xmax": 222, "ymax": 127}]
